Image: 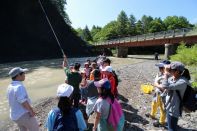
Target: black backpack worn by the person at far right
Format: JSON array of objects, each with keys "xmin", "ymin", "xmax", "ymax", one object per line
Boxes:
[{"xmin": 176, "ymin": 85, "xmax": 197, "ymax": 113}]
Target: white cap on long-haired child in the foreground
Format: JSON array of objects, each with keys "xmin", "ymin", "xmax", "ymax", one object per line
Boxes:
[{"xmin": 57, "ymin": 83, "xmax": 74, "ymax": 97}]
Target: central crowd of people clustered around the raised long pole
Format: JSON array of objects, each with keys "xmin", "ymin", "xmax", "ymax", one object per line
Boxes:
[{"xmin": 46, "ymin": 56, "xmax": 124, "ymax": 131}]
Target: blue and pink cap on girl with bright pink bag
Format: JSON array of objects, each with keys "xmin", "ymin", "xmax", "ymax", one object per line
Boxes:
[{"xmin": 94, "ymin": 78, "xmax": 111, "ymax": 89}]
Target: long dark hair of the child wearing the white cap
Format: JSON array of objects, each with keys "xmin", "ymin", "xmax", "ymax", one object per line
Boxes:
[{"xmin": 58, "ymin": 97, "xmax": 72, "ymax": 116}]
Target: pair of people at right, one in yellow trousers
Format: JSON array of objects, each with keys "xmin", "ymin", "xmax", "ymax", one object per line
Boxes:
[{"xmin": 145, "ymin": 60, "xmax": 190, "ymax": 131}]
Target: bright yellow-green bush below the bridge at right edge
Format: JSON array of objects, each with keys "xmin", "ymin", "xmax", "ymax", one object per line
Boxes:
[{"xmin": 170, "ymin": 42, "xmax": 197, "ymax": 65}]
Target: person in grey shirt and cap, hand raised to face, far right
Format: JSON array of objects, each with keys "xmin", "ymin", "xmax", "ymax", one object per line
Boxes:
[{"xmin": 157, "ymin": 62, "xmax": 190, "ymax": 131}]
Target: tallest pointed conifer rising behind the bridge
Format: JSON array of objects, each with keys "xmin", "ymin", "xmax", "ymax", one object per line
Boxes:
[{"xmin": 117, "ymin": 11, "xmax": 129, "ymax": 36}]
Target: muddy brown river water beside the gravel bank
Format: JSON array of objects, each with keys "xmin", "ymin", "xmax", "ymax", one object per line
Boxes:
[{"xmin": 0, "ymin": 57, "xmax": 94, "ymax": 129}]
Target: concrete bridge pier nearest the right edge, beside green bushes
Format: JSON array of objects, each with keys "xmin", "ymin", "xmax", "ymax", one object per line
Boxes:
[{"xmin": 164, "ymin": 44, "xmax": 177, "ymax": 60}]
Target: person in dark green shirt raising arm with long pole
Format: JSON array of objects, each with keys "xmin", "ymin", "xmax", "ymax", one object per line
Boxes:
[{"xmin": 63, "ymin": 56, "xmax": 82, "ymax": 107}]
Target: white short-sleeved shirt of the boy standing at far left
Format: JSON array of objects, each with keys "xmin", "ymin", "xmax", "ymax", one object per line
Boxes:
[{"xmin": 7, "ymin": 81, "xmax": 31, "ymax": 120}]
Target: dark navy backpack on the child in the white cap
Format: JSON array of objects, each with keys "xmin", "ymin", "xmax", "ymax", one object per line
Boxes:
[{"xmin": 53, "ymin": 108, "xmax": 79, "ymax": 131}]
